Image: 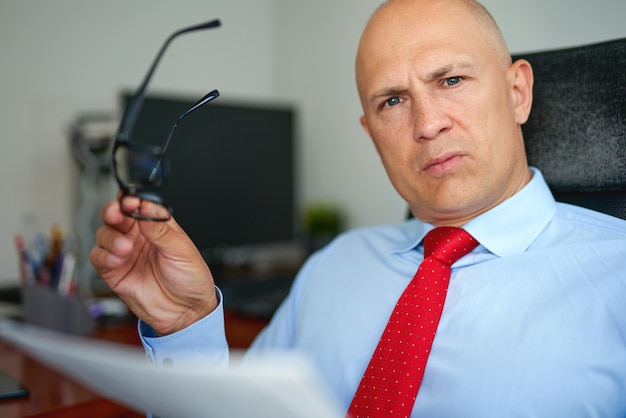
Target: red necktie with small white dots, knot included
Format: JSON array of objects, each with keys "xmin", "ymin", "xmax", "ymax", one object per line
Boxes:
[{"xmin": 348, "ymin": 227, "xmax": 478, "ymax": 417}]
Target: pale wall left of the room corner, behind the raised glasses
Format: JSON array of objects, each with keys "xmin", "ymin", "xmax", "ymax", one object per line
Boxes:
[{"xmin": 0, "ymin": 0, "xmax": 276, "ymax": 282}]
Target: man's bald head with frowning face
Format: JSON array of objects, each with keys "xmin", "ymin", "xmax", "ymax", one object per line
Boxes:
[{"xmin": 357, "ymin": 0, "xmax": 532, "ymax": 226}]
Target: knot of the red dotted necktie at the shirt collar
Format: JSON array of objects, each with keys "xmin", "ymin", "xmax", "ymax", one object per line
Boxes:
[{"xmin": 424, "ymin": 226, "xmax": 478, "ymax": 266}]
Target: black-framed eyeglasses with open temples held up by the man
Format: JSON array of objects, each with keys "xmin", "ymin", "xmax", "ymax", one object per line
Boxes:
[{"xmin": 111, "ymin": 19, "xmax": 220, "ymax": 222}]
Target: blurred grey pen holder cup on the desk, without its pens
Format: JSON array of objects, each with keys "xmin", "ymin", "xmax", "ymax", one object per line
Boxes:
[{"xmin": 22, "ymin": 286, "xmax": 96, "ymax": 335}]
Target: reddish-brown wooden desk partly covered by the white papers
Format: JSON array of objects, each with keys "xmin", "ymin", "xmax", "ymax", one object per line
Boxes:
[{"xmin": 0, "ymin": 313, "xmax": 267, "ymax": 418}]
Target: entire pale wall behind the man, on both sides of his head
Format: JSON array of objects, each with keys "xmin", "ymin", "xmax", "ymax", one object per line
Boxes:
[{"xmin": 0, "ymin": 0, "xmax": 626, "ymax": 283}]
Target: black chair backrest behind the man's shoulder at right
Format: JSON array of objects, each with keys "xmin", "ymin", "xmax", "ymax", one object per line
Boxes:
[{"xmin": 513, "ymin": 39, "xmax": 626, "ymax": 219}]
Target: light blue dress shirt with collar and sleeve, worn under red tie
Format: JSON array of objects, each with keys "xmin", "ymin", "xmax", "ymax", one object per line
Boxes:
[{"xmin": 140, "ymin": 169, "xmax": 626, "ymax": 418}]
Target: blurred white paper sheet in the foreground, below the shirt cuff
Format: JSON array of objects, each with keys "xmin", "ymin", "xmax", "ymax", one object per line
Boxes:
[{"xmin": 0, "ymin": 319, "xmax": 343, "ymax": 418}]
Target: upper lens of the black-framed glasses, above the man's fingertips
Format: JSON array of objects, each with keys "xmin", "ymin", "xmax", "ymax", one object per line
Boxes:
[{"xmin": 113, "ymin": 142, "xmax": 168, "ymax": 191}]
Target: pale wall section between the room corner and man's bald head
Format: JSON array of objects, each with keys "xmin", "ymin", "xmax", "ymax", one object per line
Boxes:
[{"xmin": 277, "ymin": 0, "xmax": 406, "ymax": 230}]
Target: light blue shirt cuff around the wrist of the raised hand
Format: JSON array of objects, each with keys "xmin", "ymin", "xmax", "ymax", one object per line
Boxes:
[{"xmin": 138, "ymin": 287, "xmax": 228, "ymax": 367}]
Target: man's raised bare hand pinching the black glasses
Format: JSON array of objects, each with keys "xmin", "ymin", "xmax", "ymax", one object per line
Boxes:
[{"xmin": 89, "ymin": 200, "xmax": 218, "ymax": 335}]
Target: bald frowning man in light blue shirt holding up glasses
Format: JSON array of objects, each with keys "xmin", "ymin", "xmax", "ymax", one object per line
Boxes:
[{"xmin": 91, "ymin": 0, "xmax": 626, "ymax": 417}]
